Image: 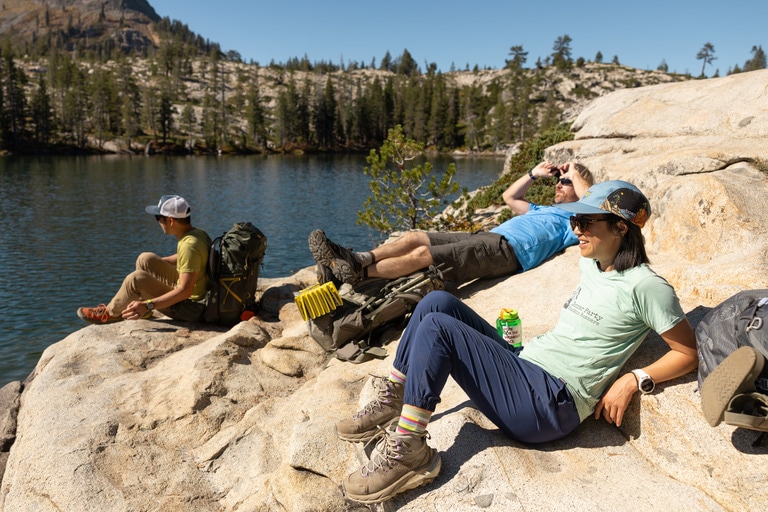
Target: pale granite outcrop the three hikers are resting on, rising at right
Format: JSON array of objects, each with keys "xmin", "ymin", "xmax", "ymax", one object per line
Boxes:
[{"xmin": 0, "ymin": 71, "xmax": 768, "ymax": 512}]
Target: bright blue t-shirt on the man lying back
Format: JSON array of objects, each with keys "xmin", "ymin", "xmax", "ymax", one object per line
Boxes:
[{"xmin": 491, "ymin": 203, "xmax": 579, "ymax": 272}]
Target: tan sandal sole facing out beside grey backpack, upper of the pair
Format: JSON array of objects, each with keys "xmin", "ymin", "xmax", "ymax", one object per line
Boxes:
[{"xmin": 701, "ymin": 347, "xmax": 765, "ymax": 427}]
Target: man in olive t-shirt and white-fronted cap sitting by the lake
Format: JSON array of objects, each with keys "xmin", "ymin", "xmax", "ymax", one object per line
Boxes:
[{"xmin": 77, "ymin": 195, "xmax": 211, "ymax": 324}]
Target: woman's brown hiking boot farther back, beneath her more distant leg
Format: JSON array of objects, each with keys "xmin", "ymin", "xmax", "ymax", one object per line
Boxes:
[{"xmin": 336, "ymin": 377, "xmax": 405, "ymax": 442}]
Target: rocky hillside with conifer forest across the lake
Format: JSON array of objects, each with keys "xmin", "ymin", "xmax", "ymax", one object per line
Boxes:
[{"xmin": 0, "ymin": 0, "xmax": 764, "ymax": 153}]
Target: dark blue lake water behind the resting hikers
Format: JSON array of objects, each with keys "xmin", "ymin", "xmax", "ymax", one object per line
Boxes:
[{"xmin": 0, "ymin": 155, "xmax": 503, "ymax": 387}]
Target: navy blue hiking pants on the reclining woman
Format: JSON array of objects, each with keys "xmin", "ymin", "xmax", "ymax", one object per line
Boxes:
[{"xmin": 393, "ymin": 291, "xmax": 579, "ymax": 443}]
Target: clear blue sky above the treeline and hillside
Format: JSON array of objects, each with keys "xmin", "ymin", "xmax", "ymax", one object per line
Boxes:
[{"xmin": 149, "ymin": 0, "xmax": 768, "ymax": 76}]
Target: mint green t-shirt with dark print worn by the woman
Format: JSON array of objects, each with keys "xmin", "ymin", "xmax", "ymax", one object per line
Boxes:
[{"xmin": 520, "ymin": 258, "xmax": 685, "ymax": 421}]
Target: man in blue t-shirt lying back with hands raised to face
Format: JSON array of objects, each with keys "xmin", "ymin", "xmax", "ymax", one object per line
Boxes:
[{"xmin": 309, "ymin": 162, "xmax": 593, "ymax": 284}]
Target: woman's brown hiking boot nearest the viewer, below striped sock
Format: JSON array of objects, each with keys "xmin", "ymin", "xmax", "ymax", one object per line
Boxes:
[{"xmin": 342, "ymin": 429, "xmax": 442, "ymax": 503}]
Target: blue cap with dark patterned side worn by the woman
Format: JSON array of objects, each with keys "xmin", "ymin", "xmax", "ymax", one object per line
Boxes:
[{"xmin": 557, "ymin": 180, "xmax": 651, "ymax": 227}]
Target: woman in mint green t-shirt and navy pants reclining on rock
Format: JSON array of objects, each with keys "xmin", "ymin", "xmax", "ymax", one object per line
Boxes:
[{"xmin": 337, "ymin": 181, "xmax": 698, "ymax": 503}]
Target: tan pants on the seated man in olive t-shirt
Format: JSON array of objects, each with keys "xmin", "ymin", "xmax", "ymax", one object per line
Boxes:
[{"xmin": 107, "ymin": 252, "xmax": 179, "ymax": 316}]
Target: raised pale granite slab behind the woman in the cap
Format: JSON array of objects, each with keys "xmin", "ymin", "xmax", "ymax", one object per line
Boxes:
[{"xmin": 553, "ymin": 70, "xmax": 768, "ymax": 304}]
